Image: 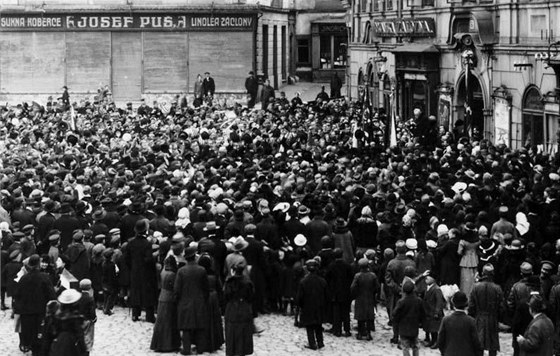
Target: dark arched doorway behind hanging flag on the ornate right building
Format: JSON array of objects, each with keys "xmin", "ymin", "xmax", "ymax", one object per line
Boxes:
[{"xmin": 455, "ymin": 75, "xmax": 488, "ymax": 137}]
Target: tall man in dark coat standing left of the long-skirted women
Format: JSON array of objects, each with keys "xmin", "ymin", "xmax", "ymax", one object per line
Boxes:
[{"xmin": 124, "ymin": 219, "xmax": 157, "ymax": 323}]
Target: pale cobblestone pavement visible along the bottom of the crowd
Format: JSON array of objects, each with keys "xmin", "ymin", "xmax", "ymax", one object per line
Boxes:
[{"xmin": 0, "ymin": 298, "xmax": 513, "ymax": 356}]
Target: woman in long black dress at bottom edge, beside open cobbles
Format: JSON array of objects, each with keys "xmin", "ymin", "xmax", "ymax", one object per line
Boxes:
[{"xmin": 224, "ymin": 263, "xmax": 254, "ymax": 356}]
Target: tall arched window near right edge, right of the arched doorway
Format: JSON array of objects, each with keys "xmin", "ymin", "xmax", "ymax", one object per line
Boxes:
[{"xmin": 522, "ymin": 86, "xmax": 544, "ymax": 146}]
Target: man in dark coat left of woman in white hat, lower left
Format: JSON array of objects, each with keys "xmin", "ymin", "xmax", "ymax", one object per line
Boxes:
[{"xmin": 14, "ymin": 255, "xmax": 56, "ymax": 355}]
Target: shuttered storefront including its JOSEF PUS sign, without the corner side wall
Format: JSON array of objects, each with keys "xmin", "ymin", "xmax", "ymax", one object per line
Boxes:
[{"xmin": 0, "ymin": 11, "xmax": 257, "ymax": 101}]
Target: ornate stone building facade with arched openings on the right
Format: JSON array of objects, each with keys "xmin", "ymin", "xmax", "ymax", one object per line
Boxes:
[{"xmin": 343, "ymin": 0, "xmax": 560, "ymax": 152}]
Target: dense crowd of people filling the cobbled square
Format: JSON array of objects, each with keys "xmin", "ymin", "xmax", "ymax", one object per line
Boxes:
[{"xmin": 0, "ymin": 82, "xmax": 560, "ymax": 356}]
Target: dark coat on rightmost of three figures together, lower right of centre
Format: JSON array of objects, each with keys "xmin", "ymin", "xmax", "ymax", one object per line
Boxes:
[{"xmin": 350, "ymin": 272, "xmax": 380, "ymax": 321}]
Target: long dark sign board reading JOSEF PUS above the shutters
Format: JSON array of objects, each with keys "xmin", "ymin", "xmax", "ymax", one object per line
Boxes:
[{"xmin": 0, "ymin": 13, "xmax": 256, "ymax": 31}]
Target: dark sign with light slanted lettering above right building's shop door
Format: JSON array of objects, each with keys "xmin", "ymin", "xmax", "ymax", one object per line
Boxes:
[{"xmin": 373, "ymin": 18, "xmax": 436, "ymax": 37}]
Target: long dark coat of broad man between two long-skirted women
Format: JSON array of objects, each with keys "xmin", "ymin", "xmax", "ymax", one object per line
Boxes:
[{"xmin": 173, "ymin": 261, "xmax": 210, "ymax": 330}]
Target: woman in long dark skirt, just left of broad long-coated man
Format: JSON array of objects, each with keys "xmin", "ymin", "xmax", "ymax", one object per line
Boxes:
[{"xmin": 150, "ymin": 257, "xmax": 181, "ymax": 352}]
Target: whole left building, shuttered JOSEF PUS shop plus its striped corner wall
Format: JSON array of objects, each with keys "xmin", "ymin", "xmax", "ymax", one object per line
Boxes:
[{"xmin": 0, "ymin": 0, "xmax": 295, "ymax": 102}]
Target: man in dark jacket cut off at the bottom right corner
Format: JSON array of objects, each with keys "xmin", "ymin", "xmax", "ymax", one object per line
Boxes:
[{"xmin": 517, "ymin": 295, "xmax": 554, "ymax": 356}]
